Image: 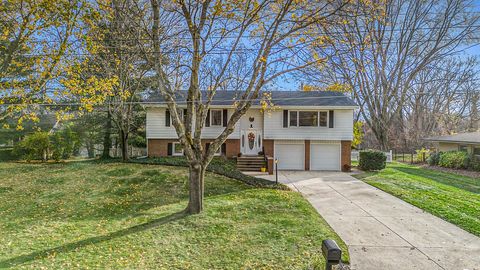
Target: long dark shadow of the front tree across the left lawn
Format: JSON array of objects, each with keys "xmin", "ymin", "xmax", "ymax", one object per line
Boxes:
[{"xmin": 0, "ymin": 211, "xmax": 187, "ymax": 268}]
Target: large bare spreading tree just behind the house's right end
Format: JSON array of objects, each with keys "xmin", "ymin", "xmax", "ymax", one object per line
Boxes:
[{"xmin": 317, "ymin": 0, "xmax": 479, "ymax": 149}]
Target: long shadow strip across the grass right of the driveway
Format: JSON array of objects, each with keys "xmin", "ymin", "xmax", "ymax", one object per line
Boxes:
[{"xmin": 391, "ymin": 166, "xmax": 480, "ymax": 194}]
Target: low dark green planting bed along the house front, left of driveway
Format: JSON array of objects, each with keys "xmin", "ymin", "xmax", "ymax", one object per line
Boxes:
[{"xmin": 131, "ymin": 157, "xmax": 289, "ymax": 190}]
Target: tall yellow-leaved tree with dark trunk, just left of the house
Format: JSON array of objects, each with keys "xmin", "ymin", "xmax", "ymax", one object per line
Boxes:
[{"xmin": 62, "ymin": 0, "xmax": 152, "ymax": 161}]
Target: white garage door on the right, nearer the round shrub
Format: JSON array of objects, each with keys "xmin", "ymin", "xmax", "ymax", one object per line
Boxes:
[{"xmin": 310, "ymin": 143, "xmax": 341, "ymax": 171}]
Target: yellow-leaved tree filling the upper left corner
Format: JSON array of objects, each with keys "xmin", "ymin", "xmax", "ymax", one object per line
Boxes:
[{"xmin": 0, "ymin": 0, "xmax": 88, "ymax": 129}]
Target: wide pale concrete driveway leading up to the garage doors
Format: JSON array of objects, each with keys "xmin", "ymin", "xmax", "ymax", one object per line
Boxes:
[{"xmin": 261, "ymin": 171, "xmax": 480, "ymax": 270}]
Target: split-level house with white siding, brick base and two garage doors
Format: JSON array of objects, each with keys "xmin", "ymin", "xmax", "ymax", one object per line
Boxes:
[{"xmin": 145, "ymin": 91, "xmax": 357, "ymax": 172}]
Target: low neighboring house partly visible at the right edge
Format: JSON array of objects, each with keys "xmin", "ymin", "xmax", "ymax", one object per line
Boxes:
[{"xmin": 426, "ymin": 132, "xmax": 480, "ymax": 157}]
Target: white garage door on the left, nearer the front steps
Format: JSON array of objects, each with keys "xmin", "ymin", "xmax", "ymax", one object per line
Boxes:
[{"xmin": 274, "ymin": 142, "xmax": 305, "ymax": 170}]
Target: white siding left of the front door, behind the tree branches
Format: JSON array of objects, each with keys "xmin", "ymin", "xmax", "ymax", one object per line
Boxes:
[{"xmin": 146, "ymin": 108, "xmax": 240, "ymax": 139}]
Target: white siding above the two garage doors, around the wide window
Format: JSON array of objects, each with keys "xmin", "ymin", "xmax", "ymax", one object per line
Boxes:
[{"xmin": 264, "ymin": 109, "xmax": 353, "ymax": 141}]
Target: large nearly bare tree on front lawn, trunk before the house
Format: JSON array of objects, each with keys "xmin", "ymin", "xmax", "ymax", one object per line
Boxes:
[{"xmin": 144, "ymin": 0, "xmax": 345, "ymax": 213}]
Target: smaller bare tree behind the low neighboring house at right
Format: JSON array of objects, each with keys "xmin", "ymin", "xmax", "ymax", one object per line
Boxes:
[{"xmin": 397, "ymin": 58, "xmax": 478, "ymax": 148}]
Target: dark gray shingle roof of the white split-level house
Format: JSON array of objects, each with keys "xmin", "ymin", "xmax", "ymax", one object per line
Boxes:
[{"xmin": 144, "ymin": 91, "xmax": 358, "ymax": 107}]
